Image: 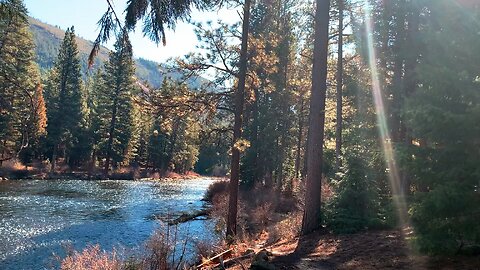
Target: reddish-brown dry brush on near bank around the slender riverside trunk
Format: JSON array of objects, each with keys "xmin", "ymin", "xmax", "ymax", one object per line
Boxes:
[{"xmin": 205, "ymin": 181, "xmax": 301, "ymax": 253}]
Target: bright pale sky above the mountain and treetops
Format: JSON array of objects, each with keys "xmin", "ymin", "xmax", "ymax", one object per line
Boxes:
[{"xmin": 24, "ymin": 0, "xmax": 240, "ymax": 63}]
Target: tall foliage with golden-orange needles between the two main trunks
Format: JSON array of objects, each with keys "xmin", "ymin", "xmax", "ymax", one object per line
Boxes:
[{"xmin": 241, "ymin": 1, "xmax": 296, "ymax": 187}]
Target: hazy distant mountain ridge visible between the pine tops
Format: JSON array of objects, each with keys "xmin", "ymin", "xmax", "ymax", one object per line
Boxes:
[{"xmin": 29, "ymin": 17, "xmax": 206, "ymax": 88}]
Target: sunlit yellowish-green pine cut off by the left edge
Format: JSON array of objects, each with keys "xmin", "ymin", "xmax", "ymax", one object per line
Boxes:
[{"xmin": 0, "ymin": 0, "xmax": 45, "ymax": 161}]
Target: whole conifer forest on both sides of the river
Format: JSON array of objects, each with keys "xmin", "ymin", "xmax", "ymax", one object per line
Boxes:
[{"xmin": 0, "ymin": 0, "xmax": 480, "ymax": 269}]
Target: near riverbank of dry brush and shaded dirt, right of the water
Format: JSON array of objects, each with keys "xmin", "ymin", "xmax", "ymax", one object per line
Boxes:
[{"xmin": 198, "ymin": 182, "xmax": 480, "ymax": 270}]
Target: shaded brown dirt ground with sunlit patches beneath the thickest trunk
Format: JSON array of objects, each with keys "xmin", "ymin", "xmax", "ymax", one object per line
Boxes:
[{"xmin": 230, "ymin": 231, "xmax": 480, "ymax": 270}]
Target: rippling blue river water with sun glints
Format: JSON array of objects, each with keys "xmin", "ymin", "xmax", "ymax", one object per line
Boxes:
[{"xmin": 0, "ymin": 178, "xmax": 219, "ymax": 270}]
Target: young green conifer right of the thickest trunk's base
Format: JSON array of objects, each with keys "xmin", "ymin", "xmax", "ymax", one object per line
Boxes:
[{"xmin": 325, "ymin": 58, "xmax": 397, "ymax": 233}]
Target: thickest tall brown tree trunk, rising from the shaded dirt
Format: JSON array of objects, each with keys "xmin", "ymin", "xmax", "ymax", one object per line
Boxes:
[{"xmin": 302, "ymin": 0, "xmax": 330, "ymax": 235}]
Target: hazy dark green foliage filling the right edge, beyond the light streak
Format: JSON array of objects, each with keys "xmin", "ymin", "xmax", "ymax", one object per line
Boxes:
[{"xmin": 405, "ymin": 1, "xmax": 480, "ymax": 254}]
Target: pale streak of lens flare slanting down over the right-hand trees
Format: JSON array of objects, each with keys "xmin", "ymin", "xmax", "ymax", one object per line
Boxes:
[{"xmin": 365, "ymin": 1, "xmax": 407, "ymax": 228}]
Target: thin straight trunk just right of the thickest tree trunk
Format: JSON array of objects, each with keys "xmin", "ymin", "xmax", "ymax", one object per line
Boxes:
[{"xmin": 335, "ymin": 0, "xmax": 344, "ymax": 171}]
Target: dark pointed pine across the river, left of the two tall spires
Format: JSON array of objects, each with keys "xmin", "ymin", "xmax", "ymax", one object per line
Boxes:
[{"xmin": 46, "ymin": 27, "xmax": 85, "ymax": 172}]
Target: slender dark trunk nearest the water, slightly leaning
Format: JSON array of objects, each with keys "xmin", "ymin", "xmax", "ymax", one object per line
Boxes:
[{"xmin": 227, "ymin": 0, "xmax": 251, "ymax": 241}]
